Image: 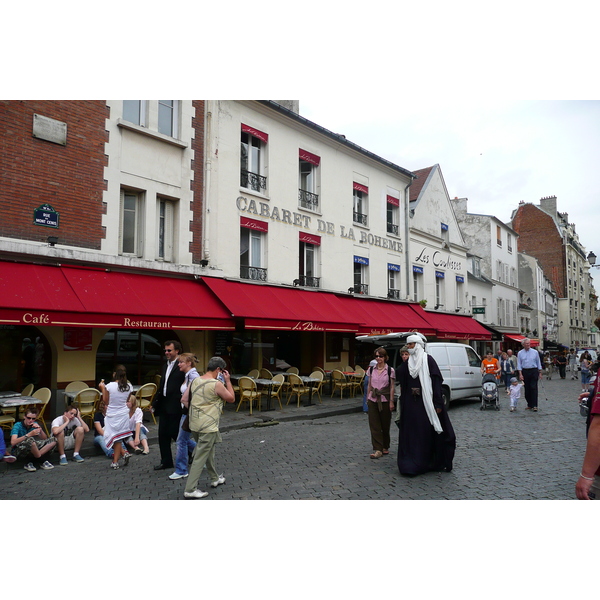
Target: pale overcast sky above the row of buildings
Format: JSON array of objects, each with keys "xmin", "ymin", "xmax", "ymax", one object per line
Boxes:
[{"xmin": 300, "ymin": 96, "xmax": 600, "ymax": 290}]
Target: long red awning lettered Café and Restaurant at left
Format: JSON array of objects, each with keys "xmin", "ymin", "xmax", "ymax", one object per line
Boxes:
[{"xmin": 0, "ymin": 263, "xmax": 235, "ymax": 329}]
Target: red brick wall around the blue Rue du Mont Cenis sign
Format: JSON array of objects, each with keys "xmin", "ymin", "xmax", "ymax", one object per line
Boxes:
[{"xmin": 0, "ymin": 100, "xmax": 109, "ymax": 250}]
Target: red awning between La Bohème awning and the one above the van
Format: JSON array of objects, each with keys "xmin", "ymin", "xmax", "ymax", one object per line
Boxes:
[{"xmin": 338, "ymin": 296, "xmax": 435, "ymax": 336}]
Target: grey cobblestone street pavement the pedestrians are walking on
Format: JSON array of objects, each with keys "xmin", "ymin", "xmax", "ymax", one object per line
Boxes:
[{"xmin": 0, "ymin": 379, "xmax": 585, "ymax": 500}]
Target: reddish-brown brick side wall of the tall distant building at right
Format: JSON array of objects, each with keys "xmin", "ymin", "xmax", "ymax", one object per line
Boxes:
[{"xmin": 512, "ymin": 204, "xmax": 567, "ymax": 298}]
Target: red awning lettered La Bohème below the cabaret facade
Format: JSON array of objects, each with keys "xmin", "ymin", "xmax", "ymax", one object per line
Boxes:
[{"xmin": 203, "ymin": 277, "xmax": 361, "ymax": 333}]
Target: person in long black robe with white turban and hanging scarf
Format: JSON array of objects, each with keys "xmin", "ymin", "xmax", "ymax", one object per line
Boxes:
[{"xmin": 396, "ymin": 335, "xmax": 456, "ymax": 476}]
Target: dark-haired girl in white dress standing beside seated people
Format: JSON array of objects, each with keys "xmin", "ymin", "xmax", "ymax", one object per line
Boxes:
[{"xmin": 98, "ymin": 365, "xmax": 133, "ymax": 469}]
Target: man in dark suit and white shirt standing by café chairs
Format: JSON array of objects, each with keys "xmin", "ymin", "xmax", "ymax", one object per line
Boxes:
[{"xmin": 153, "ymin": 341, "xmax": 185, "ymax": 471}]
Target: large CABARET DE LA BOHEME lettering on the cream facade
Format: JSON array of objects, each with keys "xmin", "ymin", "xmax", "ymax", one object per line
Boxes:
[{"xmin": 235, "ymin": 196, "xmax": 402, "ymax": 253}]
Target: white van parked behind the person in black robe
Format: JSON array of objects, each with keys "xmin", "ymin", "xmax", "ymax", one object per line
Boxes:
[{"xmin": 356, "ymin": 332, "xmax": 481, "ymax": 404}]
